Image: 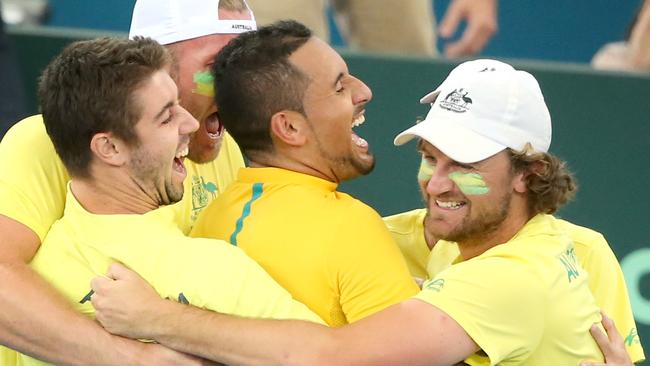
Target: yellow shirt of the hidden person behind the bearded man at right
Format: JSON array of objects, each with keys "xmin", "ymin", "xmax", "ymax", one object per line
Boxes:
[{"xmin": 384, "ymin": 209, "xmax": 645, "ymax": 362}]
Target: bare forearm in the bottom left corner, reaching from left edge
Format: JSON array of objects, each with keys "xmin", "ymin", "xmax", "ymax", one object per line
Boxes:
[{"xmin": 0, "ymin": 262, "xmax": 142, "ymax": 365}]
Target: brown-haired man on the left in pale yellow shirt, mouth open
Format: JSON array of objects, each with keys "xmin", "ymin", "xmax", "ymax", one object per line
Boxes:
[{"xmin": 12, "ymin": 37, "xmax": 319, "ymax": 365}]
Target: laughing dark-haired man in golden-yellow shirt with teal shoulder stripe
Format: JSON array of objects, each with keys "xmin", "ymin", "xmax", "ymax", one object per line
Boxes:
[{"xmin": 191, "ymin": 21, "xmax": 417, "ymax": 326}]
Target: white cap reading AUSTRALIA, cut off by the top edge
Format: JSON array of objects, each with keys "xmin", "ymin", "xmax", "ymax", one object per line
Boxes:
[{"xmin": 129, "ymin": 0, "xmax": 257, "ymax": 45}]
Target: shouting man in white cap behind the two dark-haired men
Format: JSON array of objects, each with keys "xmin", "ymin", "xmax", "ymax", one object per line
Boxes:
[{"xmin": 0, "ymin": 0, "xmax": 256, "ymax": 365}]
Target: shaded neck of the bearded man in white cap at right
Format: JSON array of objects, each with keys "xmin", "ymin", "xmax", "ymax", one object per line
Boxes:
[{"xmin": 458, "ymin": 202, "xmax": 531, "ymax": 260}]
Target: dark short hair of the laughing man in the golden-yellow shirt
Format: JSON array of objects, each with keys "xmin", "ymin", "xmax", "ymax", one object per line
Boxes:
[{"xmin": 212, "ymin": 21, "xmax": 312, "ymax": 159}]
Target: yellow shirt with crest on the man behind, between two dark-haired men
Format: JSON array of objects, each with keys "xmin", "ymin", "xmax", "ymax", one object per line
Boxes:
[{"xmin": 0, "ymin": 115, "xmax": 244, "ymax": 241}]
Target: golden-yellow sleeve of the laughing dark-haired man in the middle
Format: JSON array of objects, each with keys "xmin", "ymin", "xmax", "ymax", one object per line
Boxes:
[{"xmin": 329, "ymin": 200, "xmax": 418, "ymax": 323}]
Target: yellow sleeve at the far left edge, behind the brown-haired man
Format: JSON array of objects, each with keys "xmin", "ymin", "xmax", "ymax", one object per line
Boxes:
[{"xmin": 0, "ymin": 116, "xmax": 70, "ymax": 241}]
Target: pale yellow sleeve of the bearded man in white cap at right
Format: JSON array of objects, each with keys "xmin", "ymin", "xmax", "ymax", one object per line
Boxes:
[{"xmin": 416, "ymin": 257, "xmax": 546, "ymax": 365}]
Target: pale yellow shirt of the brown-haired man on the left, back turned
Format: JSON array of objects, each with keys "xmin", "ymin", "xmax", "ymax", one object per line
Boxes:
[{"xmin": 20, "ymin": 187, "xmax": 322, "ymax": 365}]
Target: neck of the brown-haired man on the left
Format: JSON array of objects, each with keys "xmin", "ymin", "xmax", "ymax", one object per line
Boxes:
[{"xmin": 71, "ymin": 168, "xmax": 159, "ymax": 215}]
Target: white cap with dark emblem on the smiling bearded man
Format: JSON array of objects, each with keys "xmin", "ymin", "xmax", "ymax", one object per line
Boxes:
[{"xmin": 394, "ymin": 60, "xmax": 551, "ymax": 163}]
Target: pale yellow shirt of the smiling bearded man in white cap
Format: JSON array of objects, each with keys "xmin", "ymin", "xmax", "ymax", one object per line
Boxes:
[{"xmin": 416, "ymin": 215, "xmax": 602, "ymax": 366}]
